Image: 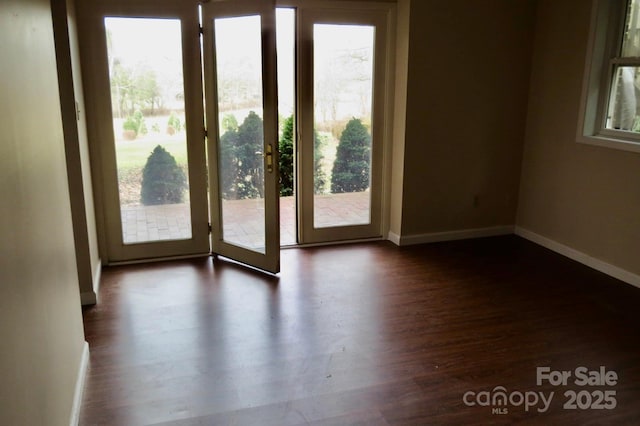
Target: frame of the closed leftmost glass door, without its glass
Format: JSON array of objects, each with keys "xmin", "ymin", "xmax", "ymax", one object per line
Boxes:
[{"xmin": 77, "ymin": 0, "xmax": 210, "ymax": 263}]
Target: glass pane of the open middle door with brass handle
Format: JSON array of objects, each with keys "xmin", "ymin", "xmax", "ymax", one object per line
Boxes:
[{"xmin": 214, "ymin": 16, "xmax": 265, "ymax": 253}]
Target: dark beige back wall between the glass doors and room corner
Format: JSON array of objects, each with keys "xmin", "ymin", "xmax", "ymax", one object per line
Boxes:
[{"xmin": 401, "ymin": 0, "xmax": 535, "ymax": 237}]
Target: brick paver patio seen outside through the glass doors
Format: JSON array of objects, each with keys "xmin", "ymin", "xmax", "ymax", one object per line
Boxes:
[{"xmin": 122, "ymin": 192, "xmax": 369, "ymax": 248}]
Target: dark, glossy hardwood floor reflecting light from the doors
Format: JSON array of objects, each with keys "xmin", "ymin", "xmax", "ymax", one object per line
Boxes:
[{"xmin": 80, "ymin": 236, "xmax": 640, "ymax": 426}]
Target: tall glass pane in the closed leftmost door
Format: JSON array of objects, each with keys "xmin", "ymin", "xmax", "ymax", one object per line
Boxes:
[{"xmin": 104, "ymin": 17, "xmax": 191, "ymax": 244}]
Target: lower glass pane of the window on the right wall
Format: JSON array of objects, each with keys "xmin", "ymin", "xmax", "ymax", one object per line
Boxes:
[{"xmin": 606, "ymin": 67, "xmax": 640, "ymax": 132}]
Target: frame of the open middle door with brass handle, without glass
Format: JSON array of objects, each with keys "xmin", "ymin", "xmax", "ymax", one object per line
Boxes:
[{"xmin": 202, "ymin": 0, "xmax": 280, "ymax": 273}]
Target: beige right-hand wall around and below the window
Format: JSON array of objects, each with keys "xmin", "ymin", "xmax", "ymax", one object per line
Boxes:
[{"xmin": 517, "ymin": 0, "xmax": 640, "ymax": 274}]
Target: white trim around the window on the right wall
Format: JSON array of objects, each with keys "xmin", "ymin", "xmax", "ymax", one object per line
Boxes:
[{"xmin": 577, "ymin": 0, "xmax": 640, "ymax": 153}]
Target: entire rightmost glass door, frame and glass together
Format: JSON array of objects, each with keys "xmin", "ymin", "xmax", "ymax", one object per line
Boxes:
[{"xmin": 298, "ymin": 8, "xmax": 387, "ymax": 243}]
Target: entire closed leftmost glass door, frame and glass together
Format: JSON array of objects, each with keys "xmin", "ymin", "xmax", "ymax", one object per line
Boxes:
[{"xmin": 77, "ymin": 0, "xmax": 210, "ymax": 263}]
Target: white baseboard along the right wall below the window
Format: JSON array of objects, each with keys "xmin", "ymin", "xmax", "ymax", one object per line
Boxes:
[{"xmin": 515, "ymin": 226, "xmax": 640, "ymax": 288}]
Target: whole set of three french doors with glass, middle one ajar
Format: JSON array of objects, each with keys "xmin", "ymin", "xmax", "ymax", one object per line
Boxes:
[{"xmin": 78, "ymin": 0, "xmax": 389, "ymax": 272}]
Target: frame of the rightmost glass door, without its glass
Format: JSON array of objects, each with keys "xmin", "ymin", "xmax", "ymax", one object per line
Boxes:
[{"xmin": 297, "ymin": 2, "xmax": 393, "ymax": 244}]
